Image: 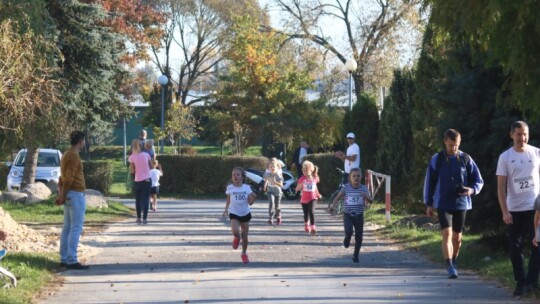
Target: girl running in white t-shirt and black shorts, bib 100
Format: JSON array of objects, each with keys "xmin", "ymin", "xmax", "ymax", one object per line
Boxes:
[{"xmin": 223, "ymin": 167, "xmax": 256, "ymax": 264}]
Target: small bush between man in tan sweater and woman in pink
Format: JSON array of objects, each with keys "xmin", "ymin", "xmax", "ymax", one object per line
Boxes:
[{"xmin": 83, "ymin": 161, "xmax": 113, "ymax": 194}]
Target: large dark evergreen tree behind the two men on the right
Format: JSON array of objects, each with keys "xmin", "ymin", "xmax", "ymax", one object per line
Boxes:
[{"xmin": 413, "ymin": 18, "xmax": 528, "ymax": 234}]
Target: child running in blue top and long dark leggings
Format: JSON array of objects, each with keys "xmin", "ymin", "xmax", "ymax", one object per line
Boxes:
[{"xmin": 329, "ymin": 168, "xmax": 373, "ymax": 263}]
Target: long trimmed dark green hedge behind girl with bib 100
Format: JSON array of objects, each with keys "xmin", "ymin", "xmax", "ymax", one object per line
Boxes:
[{"xmin": 158, "ymin": 155, "xmax": 268, "ymax": 195}]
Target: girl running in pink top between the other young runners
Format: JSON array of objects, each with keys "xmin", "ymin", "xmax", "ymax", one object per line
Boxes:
[{"xmin": 296, "ymin": 160, "xmax": 321, "ymax": 235}]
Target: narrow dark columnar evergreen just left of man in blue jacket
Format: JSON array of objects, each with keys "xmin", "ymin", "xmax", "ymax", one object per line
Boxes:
[{"xmin": 376, "ymin": 70, "xmax": 416, "ymax": 201}]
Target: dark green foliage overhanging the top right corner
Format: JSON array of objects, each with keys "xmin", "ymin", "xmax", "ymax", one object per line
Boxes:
[{"xmin": 426, "ymin": 0, "xmax": 540, "ymax": 119}]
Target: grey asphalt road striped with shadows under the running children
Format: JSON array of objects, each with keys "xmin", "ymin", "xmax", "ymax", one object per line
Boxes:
[{"xmin": 40, "ymin": 200, "xmax": 524, "ymax": 304}]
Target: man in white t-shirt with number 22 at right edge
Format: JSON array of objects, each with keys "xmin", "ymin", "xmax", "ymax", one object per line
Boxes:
[{"xmin": 496, "ymin": 121, "xmax": 540, "ymax": 297}]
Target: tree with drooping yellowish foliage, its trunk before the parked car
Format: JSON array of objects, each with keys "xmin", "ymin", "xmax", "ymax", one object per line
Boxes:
[{"xmin": 0, "ymin": 1, "xmax": 65, "ymax": 185}]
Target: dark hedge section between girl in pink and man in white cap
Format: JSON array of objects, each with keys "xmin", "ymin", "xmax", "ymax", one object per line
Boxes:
[{"xmin": 305, "ymin": 153, "xmax": 343, "ymax": 199}]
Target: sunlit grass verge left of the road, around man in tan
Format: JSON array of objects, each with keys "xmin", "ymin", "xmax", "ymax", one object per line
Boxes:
[{"xmin": 0, "ymin": 200, "xmax": 132, "ymax": 303}]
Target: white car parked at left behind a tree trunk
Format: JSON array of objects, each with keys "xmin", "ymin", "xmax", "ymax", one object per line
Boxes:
[{"xmin": 6, "ymin": 149, "xmax": 62, "ymax": 191}]
